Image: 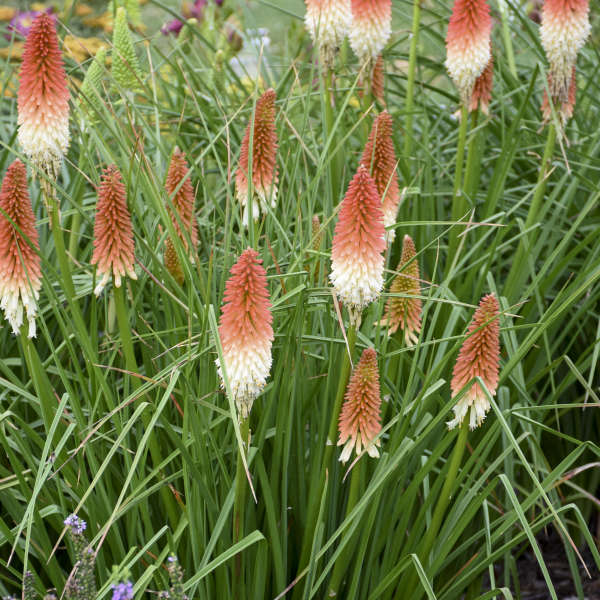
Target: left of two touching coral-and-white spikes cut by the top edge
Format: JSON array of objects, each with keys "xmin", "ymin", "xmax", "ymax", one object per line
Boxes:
[{"xmin": 304, "ymin": 0, "xmax": 352, "ymax": 69}]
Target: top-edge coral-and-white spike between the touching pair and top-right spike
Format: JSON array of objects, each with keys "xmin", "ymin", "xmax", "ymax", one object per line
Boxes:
[{"xmin": 446, "ymin": 0, "xmax": 492, "ymax": 108}]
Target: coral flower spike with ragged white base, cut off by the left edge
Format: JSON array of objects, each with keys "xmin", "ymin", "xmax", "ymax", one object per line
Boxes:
[{"xmin": 0, "ymin": 160, "xmax": 42, "ymax": 338}]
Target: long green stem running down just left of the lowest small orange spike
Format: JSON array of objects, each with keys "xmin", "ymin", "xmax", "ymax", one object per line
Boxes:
[{"xmin": 297, "ymin": 326, "xmax": 356, "ymax": 594}]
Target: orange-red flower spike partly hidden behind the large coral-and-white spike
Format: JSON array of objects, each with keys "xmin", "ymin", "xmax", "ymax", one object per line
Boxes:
[{"xmin": 360, "ymin": 110, "xmax": 400, "ymax": 243}]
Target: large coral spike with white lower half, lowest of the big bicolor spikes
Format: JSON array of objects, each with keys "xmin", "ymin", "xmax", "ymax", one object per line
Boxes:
[{"xmin": 216, "ymin": 248, "xmax": 273, "ymax": 421}]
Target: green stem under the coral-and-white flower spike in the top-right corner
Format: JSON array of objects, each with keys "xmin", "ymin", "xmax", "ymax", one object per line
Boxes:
[{"xmin": 504, "ymin": 124, "xmax": 556, "ymax": 303}]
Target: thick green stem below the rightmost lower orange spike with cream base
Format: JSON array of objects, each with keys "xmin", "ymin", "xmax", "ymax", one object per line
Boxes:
[{"xmin": 400, "ymin": 419, "xmax": 469, "ymax": 600}]
